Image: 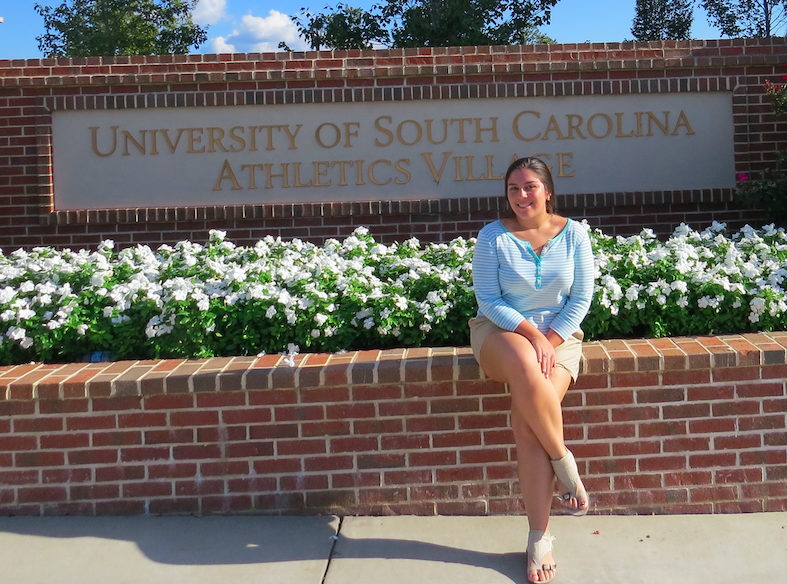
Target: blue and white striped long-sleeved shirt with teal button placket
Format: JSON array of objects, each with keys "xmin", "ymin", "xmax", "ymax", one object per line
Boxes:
[{"xmin": 473, "ymin": 219, "xmax": 593, "ymax": 340}]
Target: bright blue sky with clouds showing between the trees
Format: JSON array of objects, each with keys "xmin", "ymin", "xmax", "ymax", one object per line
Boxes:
[{"xmin": 0, "ymin": 0, "xmax": 719, "ymax": 59}]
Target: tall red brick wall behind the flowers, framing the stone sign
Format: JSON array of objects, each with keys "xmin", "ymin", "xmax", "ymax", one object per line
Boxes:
[{"xmin": 0, "ymin": 39, "xmax": 787, "ymax": 249}]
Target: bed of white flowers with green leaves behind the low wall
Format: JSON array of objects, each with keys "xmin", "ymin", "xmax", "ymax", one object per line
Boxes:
[{"xmin": 0, "ymin": 223, "xmax": 787, "ymax": 364}]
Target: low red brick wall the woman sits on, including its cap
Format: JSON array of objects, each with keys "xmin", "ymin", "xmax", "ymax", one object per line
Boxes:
[{"xmin": 0, "ymin": 333, "xmax": 787, "ymax": 515}]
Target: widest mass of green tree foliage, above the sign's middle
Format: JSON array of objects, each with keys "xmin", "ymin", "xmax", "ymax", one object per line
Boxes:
[{"xmin": 293, "ymin": 0, "xmax": 559, "ymax": 49}]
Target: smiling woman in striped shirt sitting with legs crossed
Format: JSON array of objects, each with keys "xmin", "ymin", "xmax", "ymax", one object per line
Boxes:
[{"xmin": 470, "ymin": 158, "xmax": 593, "ymax": 583}]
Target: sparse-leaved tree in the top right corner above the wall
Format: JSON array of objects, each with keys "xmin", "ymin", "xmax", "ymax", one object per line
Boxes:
[{"xmin": 701, "ymin": 0, "xmax": 787, "ymax": 38}]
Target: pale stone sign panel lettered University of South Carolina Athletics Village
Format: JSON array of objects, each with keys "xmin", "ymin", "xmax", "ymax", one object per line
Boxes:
[{"xmin": 52, "ymin": 92, "xmax": 735, "ymax": 210}]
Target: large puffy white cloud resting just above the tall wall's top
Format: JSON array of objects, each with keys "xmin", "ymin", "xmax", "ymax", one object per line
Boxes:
[{"xmin": 211, "ymin": 10, "xmax": 308, "ymax": 53}]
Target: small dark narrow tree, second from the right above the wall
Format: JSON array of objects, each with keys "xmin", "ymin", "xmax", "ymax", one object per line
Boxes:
[{"xmin": 631, "ymin": 0, "xmax": 694, "ymax": 41}]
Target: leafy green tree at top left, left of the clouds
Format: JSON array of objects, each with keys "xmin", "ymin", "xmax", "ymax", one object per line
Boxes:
[{"xmin": 35, "ymin": 0, "xmax": 207, "ymax": 57}]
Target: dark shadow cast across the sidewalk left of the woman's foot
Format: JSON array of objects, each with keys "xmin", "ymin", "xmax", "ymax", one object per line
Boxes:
[{"xmin": 0, "ymin": 516, "xmax": 524, "ymax": 582}]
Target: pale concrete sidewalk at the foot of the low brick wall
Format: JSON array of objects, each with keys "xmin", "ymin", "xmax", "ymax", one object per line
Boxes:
[{"xmin": 0, "ymin": 513, "xmax": 787, "ymax": 584}]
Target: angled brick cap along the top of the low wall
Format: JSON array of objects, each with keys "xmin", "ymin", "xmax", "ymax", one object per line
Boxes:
[{"xmin": 0, "ymin": 332, "xmax": 787, "ymax": 400}]
